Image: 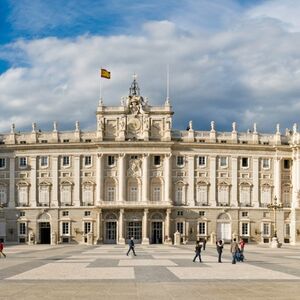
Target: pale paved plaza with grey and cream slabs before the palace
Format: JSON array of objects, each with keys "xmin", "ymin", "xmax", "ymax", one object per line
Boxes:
[{"xmin": 0, "ymin": 245, "xmax": 300, "ymax": 299}]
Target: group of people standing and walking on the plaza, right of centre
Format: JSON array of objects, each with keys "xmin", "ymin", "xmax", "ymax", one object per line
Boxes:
[{"xmin": 193, "ymin": 238, "xmax": 245, "ymax": 264}]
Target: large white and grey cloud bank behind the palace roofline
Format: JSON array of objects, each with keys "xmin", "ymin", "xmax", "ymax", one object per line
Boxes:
[{"xmin": 0, "ymin": 3, "xmax": 300, "ymax": 132}]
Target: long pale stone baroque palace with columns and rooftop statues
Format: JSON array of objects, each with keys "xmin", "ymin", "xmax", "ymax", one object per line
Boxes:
[{"xmin": 0, "ymin": 78, "xmax": 300, "ymax": 244}]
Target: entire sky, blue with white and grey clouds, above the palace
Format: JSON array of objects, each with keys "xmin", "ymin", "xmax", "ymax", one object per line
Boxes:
[{"xmin": 0, "ymin": 0, "xmax": 300, "ymax": 133}]
